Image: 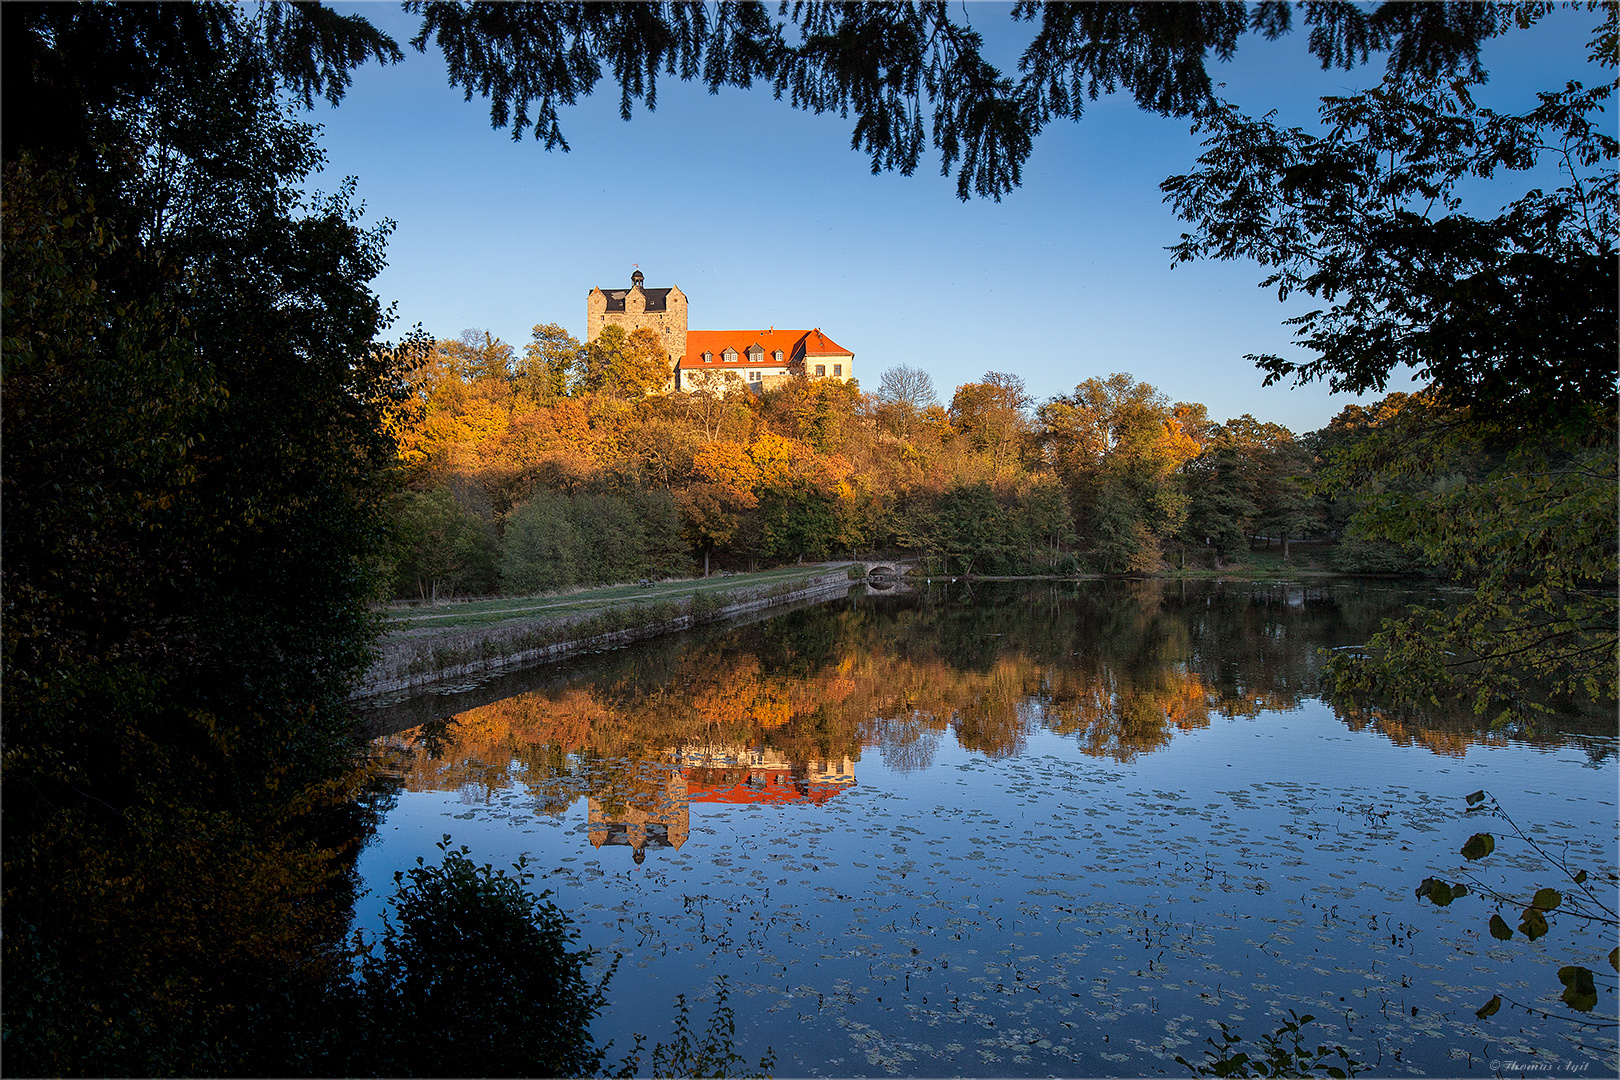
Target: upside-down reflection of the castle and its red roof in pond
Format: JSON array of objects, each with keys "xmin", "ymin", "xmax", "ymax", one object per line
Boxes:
[{"xmin": 588, "ymin": 746, "xmax": 855, "ymax": 863}]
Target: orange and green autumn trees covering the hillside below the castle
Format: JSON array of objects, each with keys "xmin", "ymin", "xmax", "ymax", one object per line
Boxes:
[{"xmin": 390, "ymin": 325, "xmax": 1418, "ymax": 597}]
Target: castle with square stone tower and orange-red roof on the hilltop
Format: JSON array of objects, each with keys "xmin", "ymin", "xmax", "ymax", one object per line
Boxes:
[{"xmin": 585, "ymin": 270, "xmax": 855, "ymax": 393}]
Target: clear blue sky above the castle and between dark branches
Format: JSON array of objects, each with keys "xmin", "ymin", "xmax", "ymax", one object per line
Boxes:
[{"xmin": 313, "ymin": 3, "xmax": 1596, "ymax": 432}]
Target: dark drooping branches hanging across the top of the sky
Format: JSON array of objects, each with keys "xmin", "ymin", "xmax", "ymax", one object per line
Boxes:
[{"xmin": 407, "ymin": 0, "xmax": 1516, "ymax": 199}]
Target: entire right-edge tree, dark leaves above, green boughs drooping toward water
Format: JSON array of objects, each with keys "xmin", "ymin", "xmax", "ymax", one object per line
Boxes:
[{"xmin": 1165, "ymin": 14, "xmax": 1620, "ymax": 716}]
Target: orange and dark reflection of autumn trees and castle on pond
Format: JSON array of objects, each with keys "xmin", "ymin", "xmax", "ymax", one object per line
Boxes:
[{"xmin": 370, "ymin": 581, "xmax": 1607, "ymax": 829}]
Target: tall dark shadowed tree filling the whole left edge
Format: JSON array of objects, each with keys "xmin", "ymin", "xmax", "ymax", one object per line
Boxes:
[{"xmin": 0, "ymin": 5, "xmax": 417, "ymax": 1075}]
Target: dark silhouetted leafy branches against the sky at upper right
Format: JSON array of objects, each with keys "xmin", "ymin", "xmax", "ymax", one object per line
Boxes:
[{"xmin": 1163, "ymin": 60, "xmax": 1620, "ymax": 442}]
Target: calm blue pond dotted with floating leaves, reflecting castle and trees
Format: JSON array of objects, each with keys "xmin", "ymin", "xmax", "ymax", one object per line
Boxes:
[{"xmin": 358, "ymin": 583, "xmax": 1617, "ymax": 1077}]
